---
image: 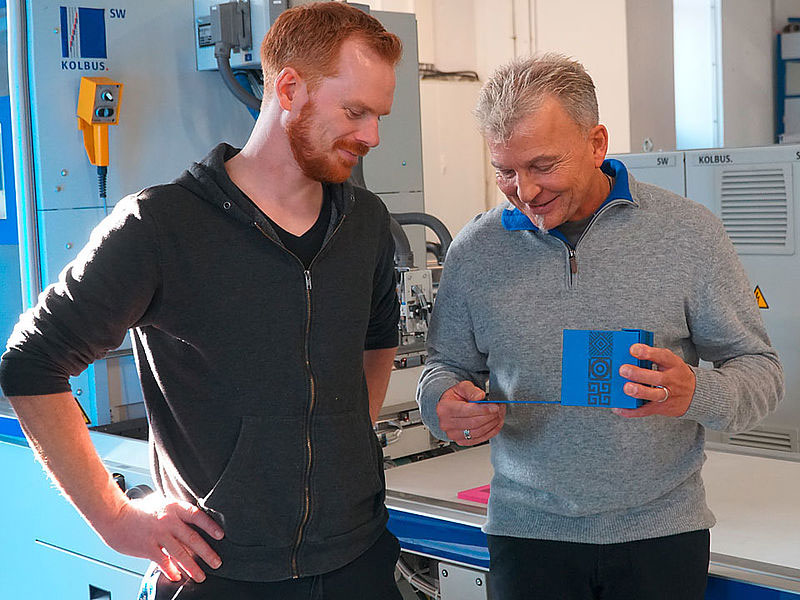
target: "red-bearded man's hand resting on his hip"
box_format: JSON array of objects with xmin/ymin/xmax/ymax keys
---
[{"xmin": 98, "ymin": 498, "xmax": 223, "ymax": 582}]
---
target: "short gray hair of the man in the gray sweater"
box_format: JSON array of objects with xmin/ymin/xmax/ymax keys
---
[{"xmin": 473, "ymin": 52, "xmax": 599, "ymax": 142}]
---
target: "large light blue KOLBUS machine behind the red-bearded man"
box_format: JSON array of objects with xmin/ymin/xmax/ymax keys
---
[{"xmin": 0, "ymin": 0, "xmax": 438, "ymax": 600}]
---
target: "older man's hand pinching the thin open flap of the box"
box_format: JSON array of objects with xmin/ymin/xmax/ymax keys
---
[{"xmin": 436, "ymin": 381, "xmax": 506, "ymax": 446}]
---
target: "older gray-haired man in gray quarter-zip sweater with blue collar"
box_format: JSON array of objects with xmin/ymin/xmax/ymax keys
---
[{"xmin": 418, "ymin": 54, "xmax": 783, "ymax": 600}]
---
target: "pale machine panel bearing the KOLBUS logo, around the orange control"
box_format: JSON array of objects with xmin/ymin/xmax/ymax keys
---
[{"xmin": 27, "ymin": 0, "xmax": 253, "ymax": 296}]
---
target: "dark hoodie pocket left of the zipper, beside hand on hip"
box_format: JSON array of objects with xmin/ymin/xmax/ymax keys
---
[{"xmin": 199, "ymin": 417, "xmax": 304, "ymax": 548}]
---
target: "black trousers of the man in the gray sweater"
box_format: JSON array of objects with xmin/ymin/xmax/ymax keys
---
[{"xmin": 487, "ymin": 529, "xmax": 710, "ymax": 600}]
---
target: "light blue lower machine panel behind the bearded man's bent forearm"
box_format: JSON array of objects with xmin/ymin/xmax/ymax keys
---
[{"xmin": 0, "ymin": 424, "xmax": 154, "ymax": 600}]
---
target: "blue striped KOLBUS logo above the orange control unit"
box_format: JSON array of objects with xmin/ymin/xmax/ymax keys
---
[{"xmin": 60, "ymin": 6, "xmax": 108, "ymax": 71}]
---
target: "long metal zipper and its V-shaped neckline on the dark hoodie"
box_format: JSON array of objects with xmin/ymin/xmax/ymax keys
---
[{"xmin": 253, "ymin": 209, "xmax": 346, "ymax": 579}]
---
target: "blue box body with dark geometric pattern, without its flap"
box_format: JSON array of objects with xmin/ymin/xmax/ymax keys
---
[{"xmin": 561, "ymin": 329, "xmax": 653, "ymax": 408}]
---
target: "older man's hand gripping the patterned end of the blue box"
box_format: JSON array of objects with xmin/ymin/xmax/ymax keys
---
[{"xmin": 612, "ymin": 344, "xmax": 695, "ymax": 417}]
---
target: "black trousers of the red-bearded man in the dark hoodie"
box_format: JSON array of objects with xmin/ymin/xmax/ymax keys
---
[{"xmin": 139, "ymin": 530, "xmax": 402, "ymax": 600}]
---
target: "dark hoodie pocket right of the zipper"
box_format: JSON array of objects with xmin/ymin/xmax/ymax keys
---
[{"xmin": 311, "ymin": 412, "xmax": 384, "ymax": 539}]
